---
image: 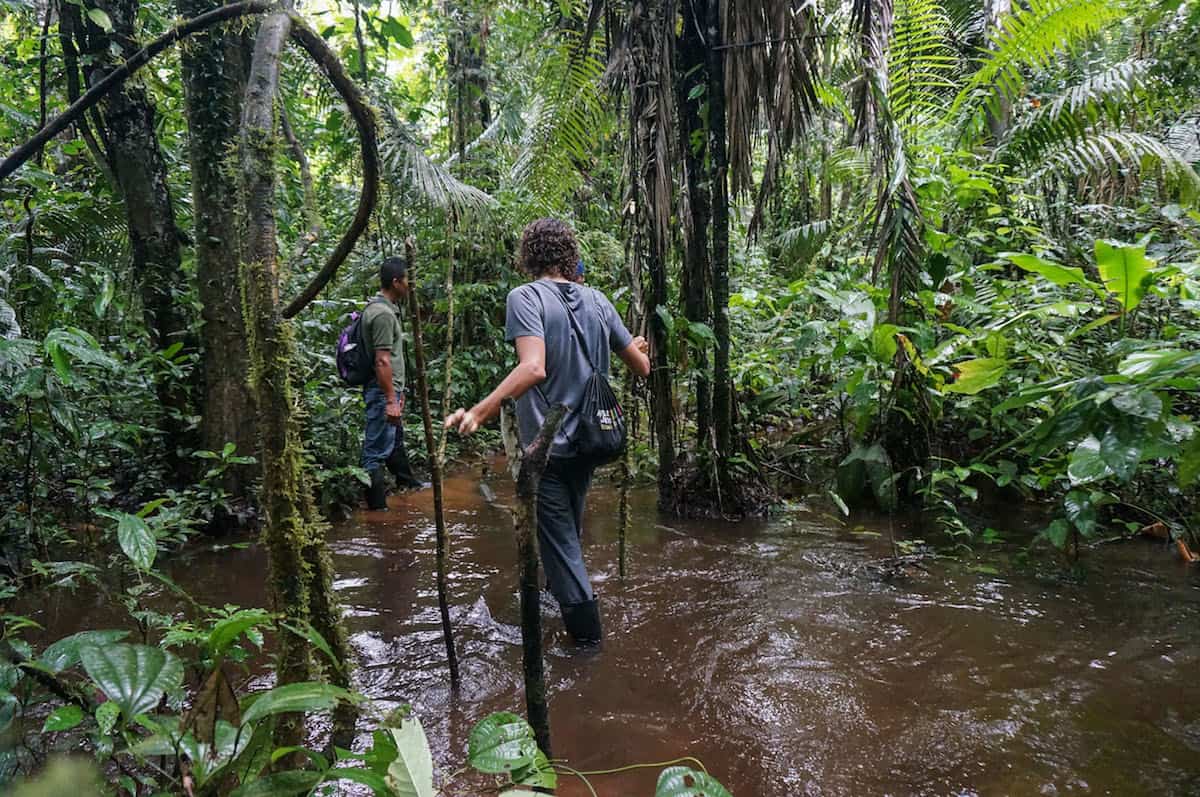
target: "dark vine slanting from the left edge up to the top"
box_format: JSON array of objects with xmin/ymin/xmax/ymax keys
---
[{"xmin": 0, "ymin": 0, "xmax": 275, "ymax": 181}]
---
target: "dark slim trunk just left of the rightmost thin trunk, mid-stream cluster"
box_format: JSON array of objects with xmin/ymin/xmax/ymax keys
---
[{"xmin": 676, "ymin": 2, "xmax": 713, "ymax": 450}]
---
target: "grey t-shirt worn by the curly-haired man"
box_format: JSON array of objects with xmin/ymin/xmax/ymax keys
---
[{"xmin": 504, "ymin": 280, "xmax": 632, "ymax": 456}]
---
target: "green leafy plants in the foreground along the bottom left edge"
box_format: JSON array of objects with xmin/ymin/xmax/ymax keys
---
[{"xmin": 0, "ymin": 607, "xmax": 728, "ymax": 797}]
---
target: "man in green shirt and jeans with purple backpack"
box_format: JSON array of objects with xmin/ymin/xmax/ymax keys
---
[{"xmin": 362, "ymin": 257, "xmax": 424, "ymax": 510}]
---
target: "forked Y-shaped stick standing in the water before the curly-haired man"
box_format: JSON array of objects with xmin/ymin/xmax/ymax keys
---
[{"xmin": 500, "ymin": 399, "xmax": 566, "ymax": 757}]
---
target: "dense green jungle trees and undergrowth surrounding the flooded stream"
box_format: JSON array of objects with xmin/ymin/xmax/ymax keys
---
[{"xmin": 0, "ymin": 0, "xmax": 1200, "ymax": 796}]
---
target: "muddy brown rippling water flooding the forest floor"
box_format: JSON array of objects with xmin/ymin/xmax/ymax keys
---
[{"xmin": 23, "ymin": 472, "xmax": 1200, "ymax": 797}]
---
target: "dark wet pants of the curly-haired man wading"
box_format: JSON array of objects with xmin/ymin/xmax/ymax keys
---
[{"xmin": 538, "ymin": 459, "xmax": 595, "ymax": 606}]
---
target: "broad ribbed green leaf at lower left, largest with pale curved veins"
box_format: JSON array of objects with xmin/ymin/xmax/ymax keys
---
[{"xmin": 79, "ymin": 643, "xmax": 184, "ymax": 720}]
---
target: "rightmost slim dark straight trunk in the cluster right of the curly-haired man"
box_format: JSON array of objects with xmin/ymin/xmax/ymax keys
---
[{"xmin": 706, "ymin": 0, "xmax": 733, "ymax": 494}]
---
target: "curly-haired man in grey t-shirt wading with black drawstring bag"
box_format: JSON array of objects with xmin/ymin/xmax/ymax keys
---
[{"xmin": 445, "ymin": 218, "xmax": 650, "ymax": 645}]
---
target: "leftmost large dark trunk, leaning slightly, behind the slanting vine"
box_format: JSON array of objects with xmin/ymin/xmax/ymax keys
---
[{"xmin": 70, "ymin": 0, "xmax": 190, "ymax": 460}]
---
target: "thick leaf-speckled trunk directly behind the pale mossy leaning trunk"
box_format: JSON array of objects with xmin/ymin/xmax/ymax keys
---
[{"xmin": 176, "ymin": 0, "xmax": 257, "ymax": 498}]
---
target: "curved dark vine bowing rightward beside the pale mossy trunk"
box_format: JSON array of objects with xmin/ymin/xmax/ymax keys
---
[{"xmin": 283, "ymin": 14, "xmax": 379, "ymax": 318}]
